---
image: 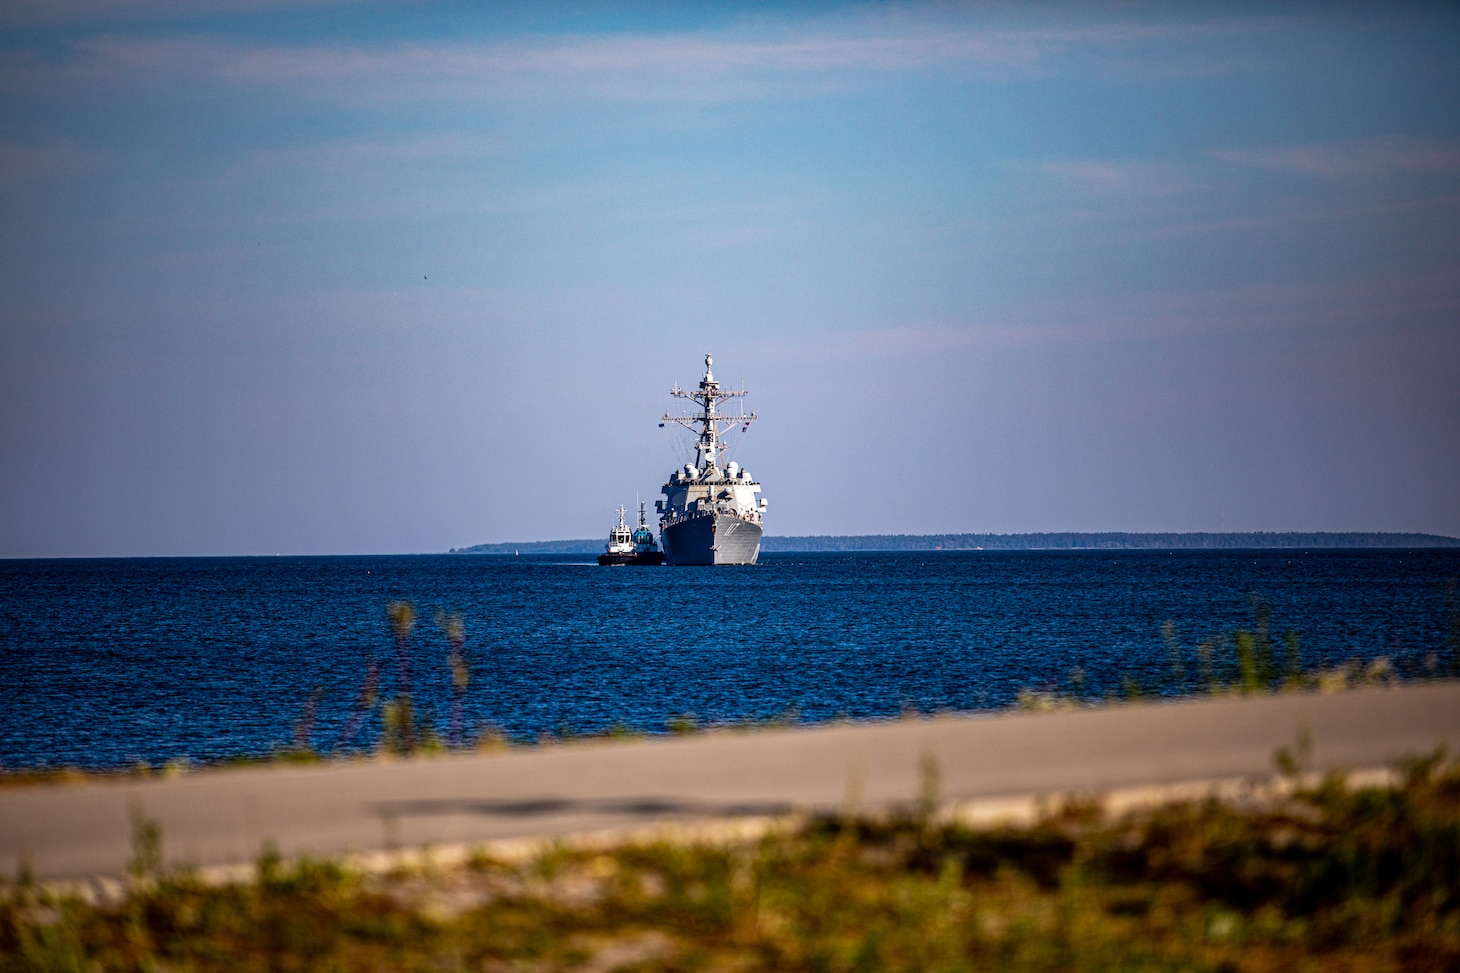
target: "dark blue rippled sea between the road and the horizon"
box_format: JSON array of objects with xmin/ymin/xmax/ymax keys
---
[{"xmin": 0, "ymin": 549, "xmax": 1460, "ymax": 767}]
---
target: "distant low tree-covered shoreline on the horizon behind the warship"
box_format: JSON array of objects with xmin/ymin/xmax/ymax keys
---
[{"xmin": 448, "ymin": 530, "xmax": 1460, "ymax": 554}]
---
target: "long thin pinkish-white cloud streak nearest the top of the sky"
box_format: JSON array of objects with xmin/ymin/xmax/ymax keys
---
[{"xmin": 4, "ymin": 7, "xmax": 1275, "ymax": 99}]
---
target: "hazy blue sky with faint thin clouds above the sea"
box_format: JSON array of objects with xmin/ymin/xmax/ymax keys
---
[{"xmin": 0, "ymin": 0, "xmax": 1460, "ymax": 557}]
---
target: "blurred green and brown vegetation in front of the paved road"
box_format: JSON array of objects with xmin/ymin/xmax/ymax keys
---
[{"xmin": 0, "ymin": 755, "xmax": 1460, "ymax": 970}]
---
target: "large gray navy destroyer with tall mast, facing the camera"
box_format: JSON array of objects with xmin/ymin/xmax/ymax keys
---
[{"xmin": 654, "ymin": 355, "xmax": 765, "ymax": 564}]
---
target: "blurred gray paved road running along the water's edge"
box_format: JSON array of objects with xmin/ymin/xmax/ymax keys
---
[{"xmin": 0, "ymin": 682, "xmax": 1460, "ymax": 879}]
